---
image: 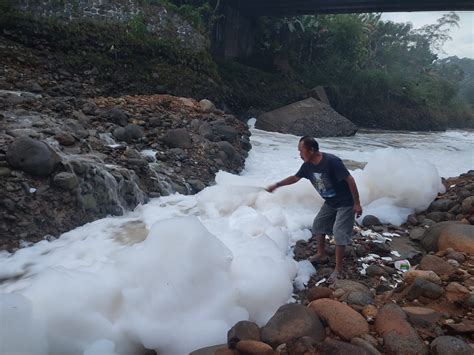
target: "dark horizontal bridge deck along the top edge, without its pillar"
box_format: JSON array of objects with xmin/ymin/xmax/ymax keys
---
[{"xmin": 239, "ymin": 0, "xmax": 474, "ymax": 16}]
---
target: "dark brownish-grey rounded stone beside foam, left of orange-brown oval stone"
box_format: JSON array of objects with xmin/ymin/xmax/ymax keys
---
[{"xmin": 261, "ymin": 301, "xmax": 326, "ymax": 347}]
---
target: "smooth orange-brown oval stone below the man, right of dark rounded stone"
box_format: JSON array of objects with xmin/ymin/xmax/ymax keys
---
[{"xmin": 308, "ymin": 298, "xmax": 369, "ymax": 340}]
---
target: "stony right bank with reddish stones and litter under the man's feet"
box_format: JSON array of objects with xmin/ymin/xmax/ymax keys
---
[{"xmin": 192, "ymin": 171, "xmax": 474, "ymax": 355}]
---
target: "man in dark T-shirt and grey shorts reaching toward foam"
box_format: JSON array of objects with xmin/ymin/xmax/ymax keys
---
[{"xmin": 267, "ymin": 136, "xmax": 362, "ymax": 283}]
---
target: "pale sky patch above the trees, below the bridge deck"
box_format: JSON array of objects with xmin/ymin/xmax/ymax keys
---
[{"xmin": 382, "ymin": 11, "xmax": 474, "ymax": 58}]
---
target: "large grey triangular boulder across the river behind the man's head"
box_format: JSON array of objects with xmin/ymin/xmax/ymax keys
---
[{"xmin": 255, "ymin": 97, "xmax": 357, "ymax": 137}]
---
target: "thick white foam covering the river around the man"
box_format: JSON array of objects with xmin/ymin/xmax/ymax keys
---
[{"xmin": 0, "ymin": 124, "xmax": 474, "ymax": 355}]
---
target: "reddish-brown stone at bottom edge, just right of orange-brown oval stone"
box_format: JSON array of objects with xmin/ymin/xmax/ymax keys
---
[{"xmin": 375, "ymin": 304, "xmax": 428, "ymax": 355}]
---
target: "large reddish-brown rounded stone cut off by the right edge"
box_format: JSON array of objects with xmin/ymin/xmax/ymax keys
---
[{"xmin": 438, "ymin": 223, "xmax": 474, "ymax": 255}]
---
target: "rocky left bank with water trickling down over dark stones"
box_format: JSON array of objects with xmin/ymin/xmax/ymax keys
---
[{"xmin": 0, "ymin": 89, "xmax": 251, "ymax": 250}]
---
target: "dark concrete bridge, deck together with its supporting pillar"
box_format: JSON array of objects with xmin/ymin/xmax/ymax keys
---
[{"xmin": 213, "ymin": 0, "xmax": 474, "ymax": 58}]
